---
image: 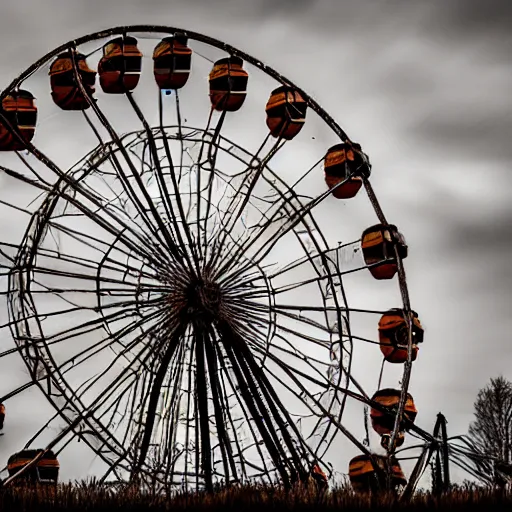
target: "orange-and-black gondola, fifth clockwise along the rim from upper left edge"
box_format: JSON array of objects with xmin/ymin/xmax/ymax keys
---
[{"xmin": 209, "ymin": 57, "xmax": 249, "ymax": 112}]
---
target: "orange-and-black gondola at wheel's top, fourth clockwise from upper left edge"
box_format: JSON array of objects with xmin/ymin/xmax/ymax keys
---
[{"xmin": 153, "ymin": 34, "xmax": 192, "ymax": 89}]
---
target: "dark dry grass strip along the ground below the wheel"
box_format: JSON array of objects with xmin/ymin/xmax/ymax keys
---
[{"xmin": 0, "ymin": 482, "xmax": 512, "ymax": 512}]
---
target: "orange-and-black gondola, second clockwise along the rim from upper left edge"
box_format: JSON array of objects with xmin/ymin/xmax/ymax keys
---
[{"xmin": 49, "ymin": 51, "xmax": 96, "ymax": 110}]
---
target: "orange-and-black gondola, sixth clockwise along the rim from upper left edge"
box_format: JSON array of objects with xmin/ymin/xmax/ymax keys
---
[{"xmin": 265, "ymin": 85, "xmax": 308, "ymax": 140}]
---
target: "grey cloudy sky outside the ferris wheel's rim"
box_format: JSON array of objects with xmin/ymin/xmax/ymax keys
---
[{"xmin": 0, "ymin": 0, "xmax": 512, "ymax": 488}]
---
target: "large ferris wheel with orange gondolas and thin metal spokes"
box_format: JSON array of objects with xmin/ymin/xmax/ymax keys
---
[{"xmin": 0, "ymin": 26, "xmax": 423, "ymax": 489}]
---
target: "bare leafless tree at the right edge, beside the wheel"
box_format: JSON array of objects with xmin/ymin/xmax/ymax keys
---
[{"xmin": 468, "ymin": 376, "xmax": 512, "ymax": 486}]
